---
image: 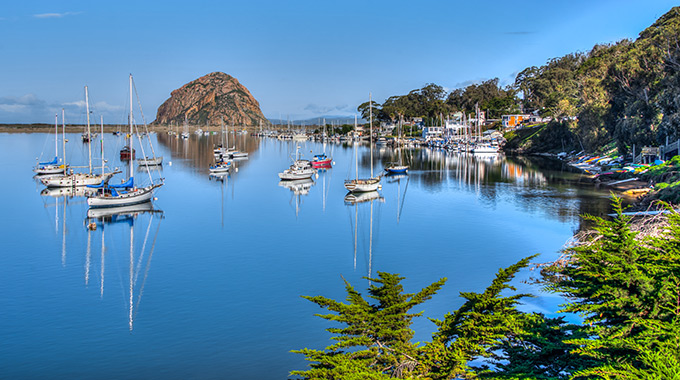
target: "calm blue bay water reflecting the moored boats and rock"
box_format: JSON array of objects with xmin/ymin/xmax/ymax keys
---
[{"xmin": 0, "ymin": 134, "xmax": 608, "ymax": 379}]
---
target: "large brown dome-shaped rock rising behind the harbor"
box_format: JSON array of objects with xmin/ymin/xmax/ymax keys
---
[{"xmin": 154, "ymin": 72, "xmax": 267, "ymax": 126}]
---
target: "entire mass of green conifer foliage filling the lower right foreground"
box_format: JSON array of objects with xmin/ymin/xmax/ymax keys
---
[{"xmin": 291, "ymin": 198, "xmax": 680, "ymax": 380}]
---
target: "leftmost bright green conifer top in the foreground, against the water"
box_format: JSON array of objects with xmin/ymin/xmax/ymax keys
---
[{"xmin": 292, "ymin": 272, "xmax": 446, "ymax": 379}]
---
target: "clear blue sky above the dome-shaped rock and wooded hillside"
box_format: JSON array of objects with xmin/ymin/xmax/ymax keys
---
[{"xmin": 0, "ymin": 0, "xmax": 676, "ymax": 124}]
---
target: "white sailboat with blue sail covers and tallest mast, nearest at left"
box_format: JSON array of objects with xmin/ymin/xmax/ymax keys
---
[{"xmin": 87, "ymin": 74, "xmax": 163, "ymax": 207}]
